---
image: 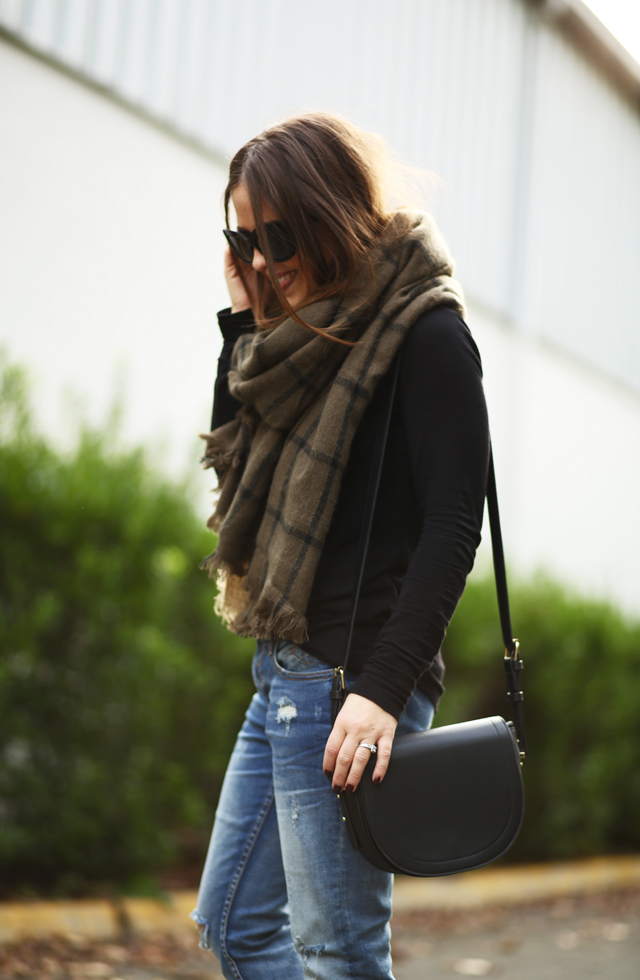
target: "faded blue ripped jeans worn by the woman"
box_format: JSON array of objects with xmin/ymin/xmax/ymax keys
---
[{"xmin": 192, "ymin": 641, "xmax": 433, "ymax": 980}]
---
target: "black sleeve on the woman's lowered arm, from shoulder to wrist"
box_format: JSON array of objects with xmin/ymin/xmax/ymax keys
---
[{"xmin": 352, "ymin": 307, "xmax": 489, "ymax": 718}]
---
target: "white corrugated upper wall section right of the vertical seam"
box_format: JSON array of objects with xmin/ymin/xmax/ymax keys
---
[{"xmin": 521, "ymin": 21, "xmax": 640, "ymax": 385}]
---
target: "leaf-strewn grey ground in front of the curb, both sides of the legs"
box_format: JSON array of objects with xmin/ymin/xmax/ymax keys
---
[{"xmin": 0, "ymin": 890, "xmax": 640, "ymax": 980}]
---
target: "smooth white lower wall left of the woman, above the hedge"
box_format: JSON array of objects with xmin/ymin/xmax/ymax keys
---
[{"xmin": 0, "ymin": 42, "xmax": 227, "ymax": 483}]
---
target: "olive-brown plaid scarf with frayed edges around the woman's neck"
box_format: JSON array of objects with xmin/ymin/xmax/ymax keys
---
[{"xmin": 203, "ymin": 211, "xmax": 464, "ymax": 643}]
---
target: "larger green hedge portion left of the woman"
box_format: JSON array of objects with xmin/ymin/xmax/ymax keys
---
[{"xmin": 0, "ymin": 360, "xmax": 252, "ymax": 894}]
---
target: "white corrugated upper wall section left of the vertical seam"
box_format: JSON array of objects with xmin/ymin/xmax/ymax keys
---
[{"xmin": 0, "ymin": 0, "xmax": 524, "ymax": 312}]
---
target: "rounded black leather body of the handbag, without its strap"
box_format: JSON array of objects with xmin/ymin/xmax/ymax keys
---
[{"xmin": 355, "ymin": 716, "xmax": 524, "ymax": 875}]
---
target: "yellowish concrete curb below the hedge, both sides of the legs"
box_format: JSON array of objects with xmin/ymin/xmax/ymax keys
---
[{"xmin": 0, "ymin": 856, "xmax": 640, "ymax": 943}]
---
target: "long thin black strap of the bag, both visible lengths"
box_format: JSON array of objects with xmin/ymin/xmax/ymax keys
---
[{"xmin": 338, "ymin": 353, "xmax": 526, "ymax": 758}]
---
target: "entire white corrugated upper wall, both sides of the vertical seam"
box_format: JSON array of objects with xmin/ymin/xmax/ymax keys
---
[{"xmin": 0, "ymin": 0, "xmax": 640, "ymax": 385}]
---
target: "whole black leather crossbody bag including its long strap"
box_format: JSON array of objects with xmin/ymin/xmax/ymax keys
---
[{"xmin": 331, "ymin": 356, "xmax": 526, "ymax": 878}]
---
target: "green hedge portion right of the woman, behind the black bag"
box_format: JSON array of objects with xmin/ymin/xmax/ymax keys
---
[{"xmin": 437, "ymin": 578, "xmax": 640, "ymax": 860}]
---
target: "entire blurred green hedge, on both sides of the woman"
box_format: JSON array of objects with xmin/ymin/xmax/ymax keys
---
[{"xmin": 0, "ymin": 360, "xmax": 640, "ymax": 896}]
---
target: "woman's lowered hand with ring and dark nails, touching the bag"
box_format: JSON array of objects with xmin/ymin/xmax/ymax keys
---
[{"xmin": 322, "ymin": 694, "xmax": 398, "ymax": 793}]
